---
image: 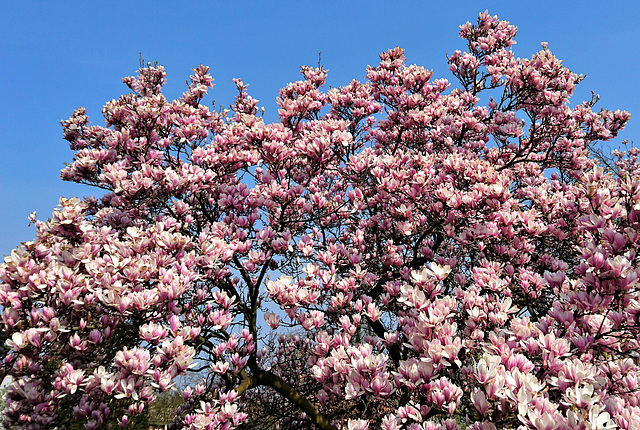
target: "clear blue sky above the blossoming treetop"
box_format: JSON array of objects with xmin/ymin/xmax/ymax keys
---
[{"xmin": 0, "ymin": 0, "xmax": 640, "ymax": 254}]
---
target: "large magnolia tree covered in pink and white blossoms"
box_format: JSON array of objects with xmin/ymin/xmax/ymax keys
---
[{"xmin": 0, "ymin": 13, "xmax": 640, "ymax": 430}]
